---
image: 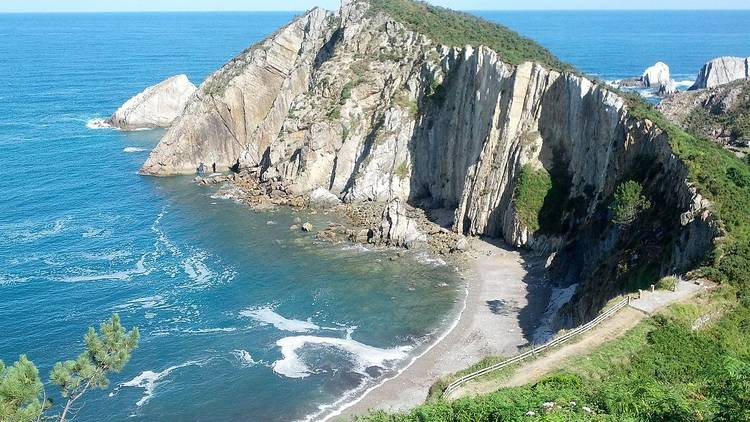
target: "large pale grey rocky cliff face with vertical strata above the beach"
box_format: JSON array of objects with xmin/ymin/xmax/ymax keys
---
[{"xmin": 142, "ymin": 0, "xmax": 715, "ymax": 319}]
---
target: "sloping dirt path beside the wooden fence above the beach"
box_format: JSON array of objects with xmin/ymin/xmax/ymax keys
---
[{"xmin": 449, "ymin": 283, "xmax": 702, "ymax": 399}]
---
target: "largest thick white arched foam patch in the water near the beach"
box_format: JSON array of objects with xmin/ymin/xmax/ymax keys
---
[{"xmin": 271, "ymin": 335, "xmax": 412, "ymax": 378}]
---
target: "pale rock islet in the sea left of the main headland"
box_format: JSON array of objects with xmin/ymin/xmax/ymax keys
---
[{"xmin": 107, "ymin": 75, "xmax": 197, "ymax": 129}]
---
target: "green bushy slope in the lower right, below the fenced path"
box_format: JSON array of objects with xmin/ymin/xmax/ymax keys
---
[{"xmin": 360, "ymin": 288, "xmax": 750, "ymax": 422}]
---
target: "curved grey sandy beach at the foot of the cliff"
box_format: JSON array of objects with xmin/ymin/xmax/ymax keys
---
[{"xmin": 328, "ymin": 239, "xmax": 549, "ymax": 420}]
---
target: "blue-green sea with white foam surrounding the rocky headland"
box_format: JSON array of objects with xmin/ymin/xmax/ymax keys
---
[{"xmin": 0, "ymin": 7, "xmax": 750, "ymax": 421}]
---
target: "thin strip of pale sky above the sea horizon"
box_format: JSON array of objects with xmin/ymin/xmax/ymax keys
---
[{"xmin": 0, "ymin": 0, "xmax": 750, "ymax": 13}]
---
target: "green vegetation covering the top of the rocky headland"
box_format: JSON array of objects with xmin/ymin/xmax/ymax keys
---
[{"xmin": 369, "ymin": 0, "xmax": 572, "ymax": 70}]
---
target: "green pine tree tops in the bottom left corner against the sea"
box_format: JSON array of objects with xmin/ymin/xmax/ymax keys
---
[{"xmin": 0, "ymin": 314, "xmax": 139, "ymax": 422}]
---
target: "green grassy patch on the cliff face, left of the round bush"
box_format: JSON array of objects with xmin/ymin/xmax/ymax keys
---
[{"xmin": 513, "ymin": 164, "xmax": 552, "ymax": 232}]
